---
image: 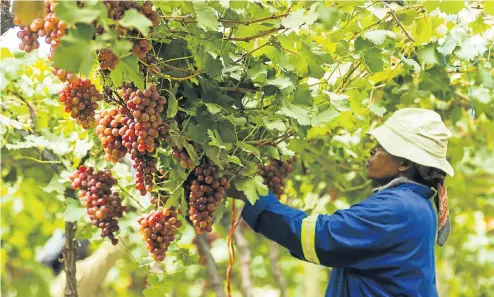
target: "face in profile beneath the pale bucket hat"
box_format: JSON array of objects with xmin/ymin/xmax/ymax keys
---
[{"xmin": 365, "ymin": 145, "xmax": 402, "ymax": 182}]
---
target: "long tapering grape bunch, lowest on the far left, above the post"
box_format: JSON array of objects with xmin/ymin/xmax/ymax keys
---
[{"xmin": 69, "ymin": 166, "xmax": 126, "ymax": 245}]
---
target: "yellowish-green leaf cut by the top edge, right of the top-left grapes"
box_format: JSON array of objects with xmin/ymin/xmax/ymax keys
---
[{"xmin": 57, "ymin": 1, "xmax": 108, "ymax": 25}]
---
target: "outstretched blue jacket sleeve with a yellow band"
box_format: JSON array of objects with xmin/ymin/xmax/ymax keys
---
[{"xmin": 242, "ymin": 193, "xmax": 408, "ymax": 268}]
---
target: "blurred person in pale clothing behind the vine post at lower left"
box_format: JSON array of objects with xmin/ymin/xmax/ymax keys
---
[{"xmin": 37, "ymin": 230, "xmax": 125, "ymax": 297}]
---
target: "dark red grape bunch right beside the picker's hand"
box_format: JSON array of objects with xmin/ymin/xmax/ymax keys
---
[{"xmin": 185, "ymin": 164, "xmax": 230, "ymax": 234}]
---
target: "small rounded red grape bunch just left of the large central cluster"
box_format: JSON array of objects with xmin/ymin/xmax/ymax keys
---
[{"xmin": 59, "ymin": 78, "xmax": 103, "ymax": 129}]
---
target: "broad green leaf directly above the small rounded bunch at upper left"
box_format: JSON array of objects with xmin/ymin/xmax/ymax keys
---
[{"xmin": 53, "ymin": 24, "xmax": 96, "ymax": 75}]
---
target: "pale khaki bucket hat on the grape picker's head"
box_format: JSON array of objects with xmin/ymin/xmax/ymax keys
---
[{"xmin": 369, "ymin": 108, "xmax": 454, "ymax": 176}]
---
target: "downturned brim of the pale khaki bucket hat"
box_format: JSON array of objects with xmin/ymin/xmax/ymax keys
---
[{"xmin": 367, "ymin": 125, "xmax": 455, "ymax": 176}]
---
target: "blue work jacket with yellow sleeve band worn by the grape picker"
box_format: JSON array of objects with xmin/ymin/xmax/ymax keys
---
[{"xmin": 242, "ymin": 183, "xmax": 438, "ymax": 297}]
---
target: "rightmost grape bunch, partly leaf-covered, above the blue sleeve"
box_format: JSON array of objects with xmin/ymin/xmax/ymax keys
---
[{"xmin": 259, "ymin": 157, "xmax": 296, "ymax": 199}]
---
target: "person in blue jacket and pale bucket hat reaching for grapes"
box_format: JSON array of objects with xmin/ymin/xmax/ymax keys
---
[{"xmin": 229, "ymin": 108, "xmax": 454, "ymax": 297}]
